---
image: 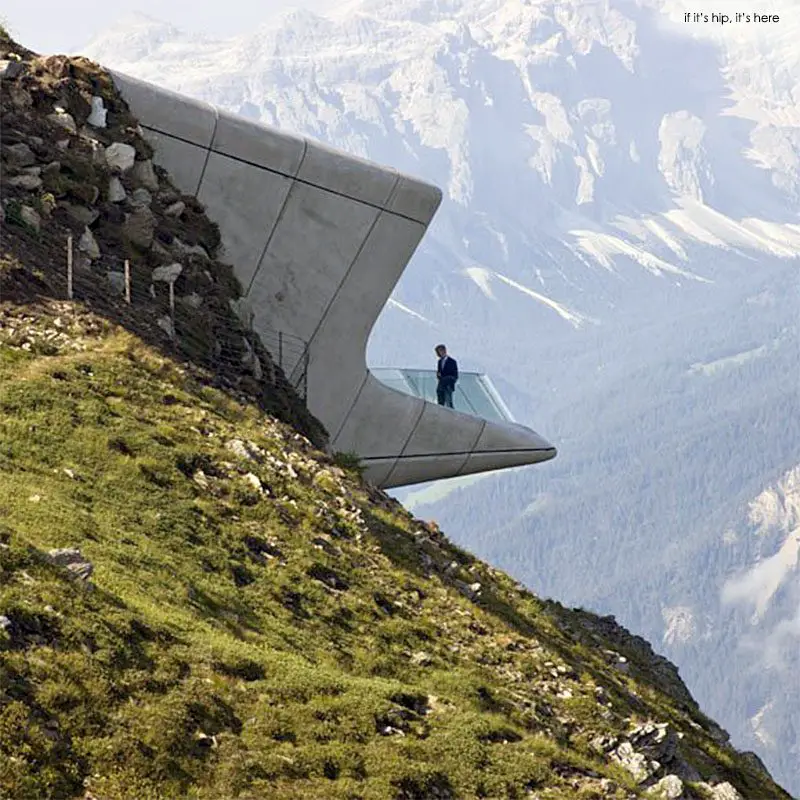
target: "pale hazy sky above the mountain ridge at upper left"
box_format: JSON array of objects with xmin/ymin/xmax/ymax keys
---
[{"xmin": 0, "ymin": 0, "xmax": 335, "ymax": 53}]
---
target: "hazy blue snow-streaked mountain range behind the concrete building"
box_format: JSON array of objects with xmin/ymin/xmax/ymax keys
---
[{"xmin": 83, "ymin": 0, "xmax": 800, "ymax": 792}]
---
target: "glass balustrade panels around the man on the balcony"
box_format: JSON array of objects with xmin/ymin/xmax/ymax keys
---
[{"xmin": 370, "ymin": 367, "xmax": 515, "ymax": 422}]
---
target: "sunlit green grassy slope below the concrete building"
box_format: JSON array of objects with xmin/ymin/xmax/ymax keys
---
[{"xmin": 0, "ymin": 304, "xmax": 786, "ymax": 800}]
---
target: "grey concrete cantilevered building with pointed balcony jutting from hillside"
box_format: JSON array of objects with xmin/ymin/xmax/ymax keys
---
[{"xmin": 112, "ymin": 73, "xmax": 556, "ymax": 488}]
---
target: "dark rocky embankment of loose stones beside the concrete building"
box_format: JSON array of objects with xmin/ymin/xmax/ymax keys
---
[{"xmin": 0, "ymin": 29, "xmax": 327, "ymax": 447}]
